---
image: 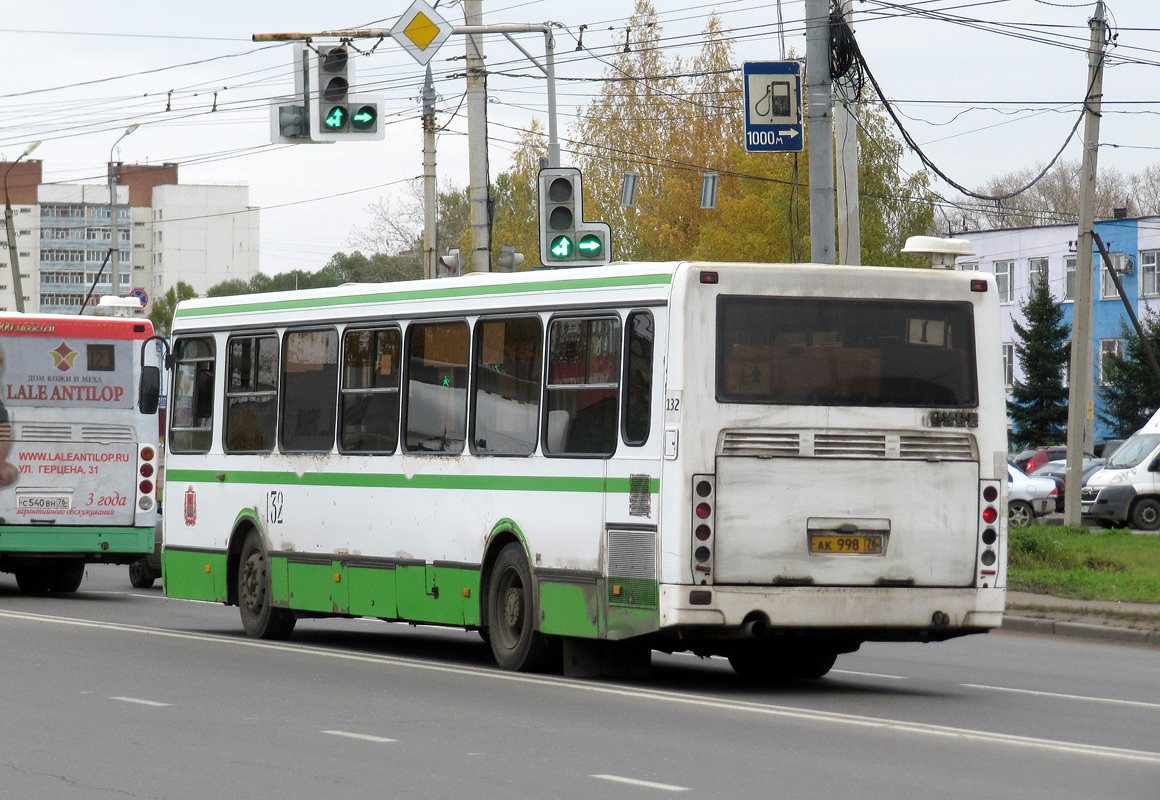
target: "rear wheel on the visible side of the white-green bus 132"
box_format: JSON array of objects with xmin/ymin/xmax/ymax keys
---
[{"xmin": 487, "ymin": 541, "xmax": 560, "ymax": 672}]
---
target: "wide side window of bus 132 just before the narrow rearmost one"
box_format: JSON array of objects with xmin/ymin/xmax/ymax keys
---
[{"xmin": 544, "ymin": 317, "xmax": 621, "ymax": 456}]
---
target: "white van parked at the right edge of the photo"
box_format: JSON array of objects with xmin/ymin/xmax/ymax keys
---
[{"xmin": 1080, "ymin": 410, "xmax": 1160, "ymax": 531}]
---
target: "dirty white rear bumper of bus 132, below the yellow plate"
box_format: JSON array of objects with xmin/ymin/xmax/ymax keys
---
[{"xmin": 660, "ymin": 584, "xmax": 1006, "ymax": 641}]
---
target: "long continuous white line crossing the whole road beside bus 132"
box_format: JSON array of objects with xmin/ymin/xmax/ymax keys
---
[{"xmin": 0, "ymin": 610, "xmax": 1160, "ymax": 765}]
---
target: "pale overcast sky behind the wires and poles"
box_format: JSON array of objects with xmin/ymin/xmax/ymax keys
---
[{"xmin": 0, "ymin": 0, "xmax": 1160, "ymax": 280}]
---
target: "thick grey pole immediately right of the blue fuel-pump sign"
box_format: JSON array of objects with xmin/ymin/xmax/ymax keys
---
[{"xmin": 805, "ymin": 0, "xmax": 834, "ymax": 264}]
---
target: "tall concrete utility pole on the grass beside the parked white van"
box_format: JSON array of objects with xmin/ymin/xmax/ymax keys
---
[{"xmin": 1064, "ymin": 1, "xmax": 1104, "ymax": 528}]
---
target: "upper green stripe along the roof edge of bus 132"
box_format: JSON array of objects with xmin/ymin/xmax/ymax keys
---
[{"xmin": 174, "ymin": 272, "xmax": 673, "ymax": 319}]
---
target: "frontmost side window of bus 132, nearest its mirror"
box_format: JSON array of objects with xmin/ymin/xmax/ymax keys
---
[{"xmin": 169, "ymin": 337, "xmax": 213, "ymax": 453}]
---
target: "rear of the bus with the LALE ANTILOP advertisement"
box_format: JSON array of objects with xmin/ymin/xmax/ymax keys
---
[{"xmin": 0, "ymin": 314, "xmax": 158, "ymax": 592}]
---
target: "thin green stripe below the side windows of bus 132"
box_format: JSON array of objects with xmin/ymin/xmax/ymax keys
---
[{"xmin": 166, "ymin": 467, "xmax": 660, "ymax": 494}]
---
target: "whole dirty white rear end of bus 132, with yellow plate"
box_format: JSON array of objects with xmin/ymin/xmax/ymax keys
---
[{"xmin": 661, "ymin": 259, "xmax": 1006, "ymax": 674}]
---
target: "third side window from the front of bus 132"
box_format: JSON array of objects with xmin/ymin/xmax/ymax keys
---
[{"xmin": 281, "ymin": 330, "xmax": 339, "ymax": 452}]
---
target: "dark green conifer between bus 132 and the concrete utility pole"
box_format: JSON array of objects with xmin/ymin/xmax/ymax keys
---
[{"xmin": 1007, "ymin": 273, "xmax": 1071, "ymax": 448}]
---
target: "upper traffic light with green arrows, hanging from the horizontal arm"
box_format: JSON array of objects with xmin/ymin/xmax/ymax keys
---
[{"xmin": 309, "ymin": 44, "xmax": 386, "ymax": 141}]
